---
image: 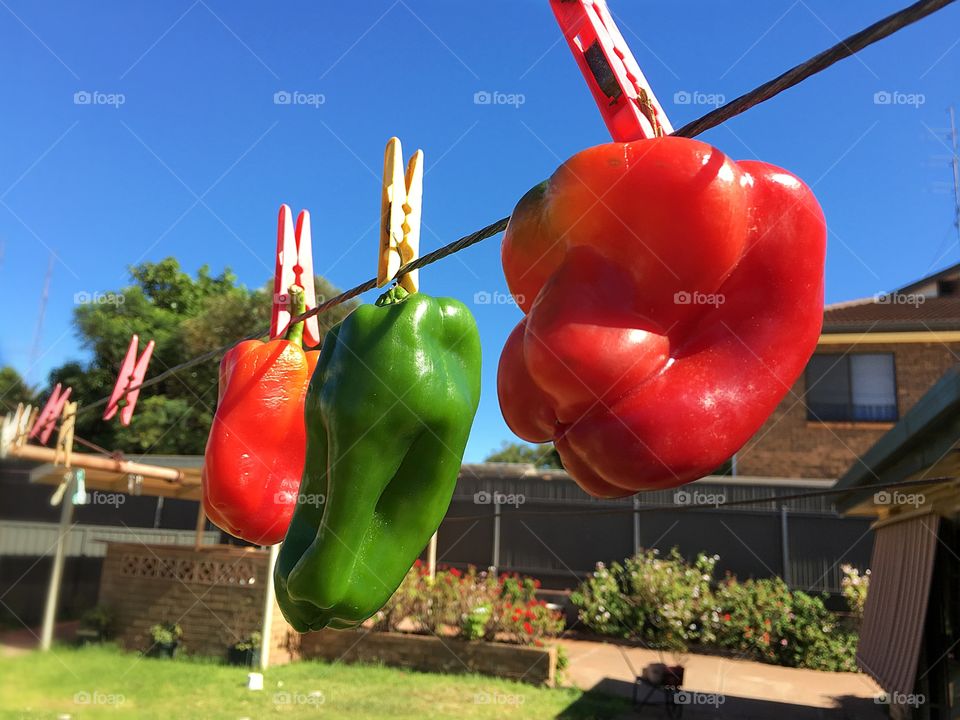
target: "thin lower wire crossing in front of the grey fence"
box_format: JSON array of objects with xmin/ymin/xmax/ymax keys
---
[{"xmin": 443, "ymin": 477, "xmax": 960, "ymax": 522}]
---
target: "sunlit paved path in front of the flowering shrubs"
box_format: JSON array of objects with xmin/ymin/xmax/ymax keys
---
[{"xmin": 560, "ymin": 640, "xmax": 887, "ymax": 720}]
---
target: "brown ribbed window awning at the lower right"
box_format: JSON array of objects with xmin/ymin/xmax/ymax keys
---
[{"xmin": 857, "ymin": 514, "xmax": 940, "ymax": 695}]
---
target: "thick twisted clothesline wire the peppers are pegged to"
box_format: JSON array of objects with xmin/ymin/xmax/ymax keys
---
[{"xmin": 28, "ymin": 0, "xmax": 956, "ymax": 417}]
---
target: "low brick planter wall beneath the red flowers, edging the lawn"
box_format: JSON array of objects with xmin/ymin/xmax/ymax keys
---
[{"xmin": 301, "ymin": 630, "xmax": 557, "ymax": 685}]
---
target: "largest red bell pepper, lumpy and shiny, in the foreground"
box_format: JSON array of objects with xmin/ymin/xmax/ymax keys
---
[{"xmin": 498, "ymin": 137, "xmax": 826, "ymax": 497}]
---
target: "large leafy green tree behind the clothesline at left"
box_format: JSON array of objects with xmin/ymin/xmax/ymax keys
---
[{"xmin": 44, "ymin": 258, "xmax": 353, "ymax": 455}]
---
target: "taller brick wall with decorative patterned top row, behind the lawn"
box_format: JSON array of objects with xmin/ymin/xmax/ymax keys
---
[{"xmin": 99, "ymin": 543, "xmax": 299, "ymax": 664}]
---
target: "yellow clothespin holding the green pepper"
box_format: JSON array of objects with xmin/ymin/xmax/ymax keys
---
[{"xmin": 377, "ymin": 137, "xmax": 423, "ymax": 292}]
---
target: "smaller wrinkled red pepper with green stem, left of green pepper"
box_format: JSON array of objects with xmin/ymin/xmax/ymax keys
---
[{"xmin": 203, "ymin": 293, "xmax": 323, "ymax": 545}]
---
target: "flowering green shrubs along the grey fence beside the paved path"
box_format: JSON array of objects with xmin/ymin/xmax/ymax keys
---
[{"xmin": 571, "ymin": 549, "xmax": 857, "ymax": 670}]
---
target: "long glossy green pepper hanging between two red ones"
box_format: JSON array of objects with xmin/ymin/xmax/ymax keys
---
[{"xmin": 274, "ymin": 287, "xmax": 480, "ymax": 632}]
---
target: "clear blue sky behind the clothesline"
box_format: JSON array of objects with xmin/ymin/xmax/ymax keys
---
[{"xmin": 0, "ymin": 0, "xmax": 960, "ymax": 460}]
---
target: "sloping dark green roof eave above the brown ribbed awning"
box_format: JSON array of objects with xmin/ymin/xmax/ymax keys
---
[{"xmin": 835, "ymin": 366, "xmax": 960, "ymax": 514}]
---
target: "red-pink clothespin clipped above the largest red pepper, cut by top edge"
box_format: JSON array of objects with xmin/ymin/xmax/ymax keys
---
[{"xmin": 550, "ymin": 0, "xmax": 673, "ymax": 142}]
